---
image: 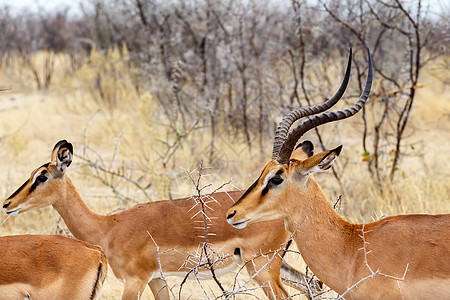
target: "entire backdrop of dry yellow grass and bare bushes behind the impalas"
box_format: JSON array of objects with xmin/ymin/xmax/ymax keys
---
[{"xmin": 0, "ymin": 0, "xmax": 450, "ymax": 299}]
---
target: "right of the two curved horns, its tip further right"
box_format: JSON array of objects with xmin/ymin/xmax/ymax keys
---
[{"xmin": 277, "ymin": 49, "xmax": 373, "ymax": 164}]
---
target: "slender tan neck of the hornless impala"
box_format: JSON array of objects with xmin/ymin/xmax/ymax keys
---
[{"xmin": 53, "ymin": 177, "xmax": 109, "ymax": 246}]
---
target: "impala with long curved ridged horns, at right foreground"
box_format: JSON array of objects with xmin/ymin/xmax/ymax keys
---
[{"xmin": 227, "ymin": 48, "xmax": 450, "ymax": 299}]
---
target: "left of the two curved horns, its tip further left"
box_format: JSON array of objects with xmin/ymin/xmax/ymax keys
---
[{"xmin": 272, "ymin": 48, "xmax": 352, "ymax": 159}]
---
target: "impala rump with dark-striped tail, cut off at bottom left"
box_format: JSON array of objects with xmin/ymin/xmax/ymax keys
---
[{"xmin": 0, "ymin": 235, "xmax": 108, "ymax": 300}]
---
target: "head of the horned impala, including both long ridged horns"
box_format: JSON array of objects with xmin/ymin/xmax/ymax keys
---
[{"xmin": 227, "ymin": 49, "xmax": 372, "ymax": 228}]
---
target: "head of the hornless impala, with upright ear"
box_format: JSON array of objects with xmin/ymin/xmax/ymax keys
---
[{"xmin": 3, "ymin": 140, "xmax": 73, "ymax": 216}]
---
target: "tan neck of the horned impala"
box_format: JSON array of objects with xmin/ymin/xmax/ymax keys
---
[{"xmin": 285, "ymin": 178, "xmax": 358, "ymax": 293}]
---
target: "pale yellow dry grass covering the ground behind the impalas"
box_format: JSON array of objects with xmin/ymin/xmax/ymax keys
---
[{"xmin": 0, "ymin": 53, "xmax": 450, "ymax": 299}]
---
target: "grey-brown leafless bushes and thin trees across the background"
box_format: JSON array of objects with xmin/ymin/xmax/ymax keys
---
[{"xmin": 0, "ymin": 0, "xmax": 449, "ymax": 178}]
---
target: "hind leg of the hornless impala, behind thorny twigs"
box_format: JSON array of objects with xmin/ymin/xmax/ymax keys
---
[{"xmin": 247, "ymin": 256, "xmax": 289, "ymax": 299}]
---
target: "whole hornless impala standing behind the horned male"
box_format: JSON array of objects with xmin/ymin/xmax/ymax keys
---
[{"xmin": 3, "ymin": 140, "xmax": 316, "ymax": 299}]
